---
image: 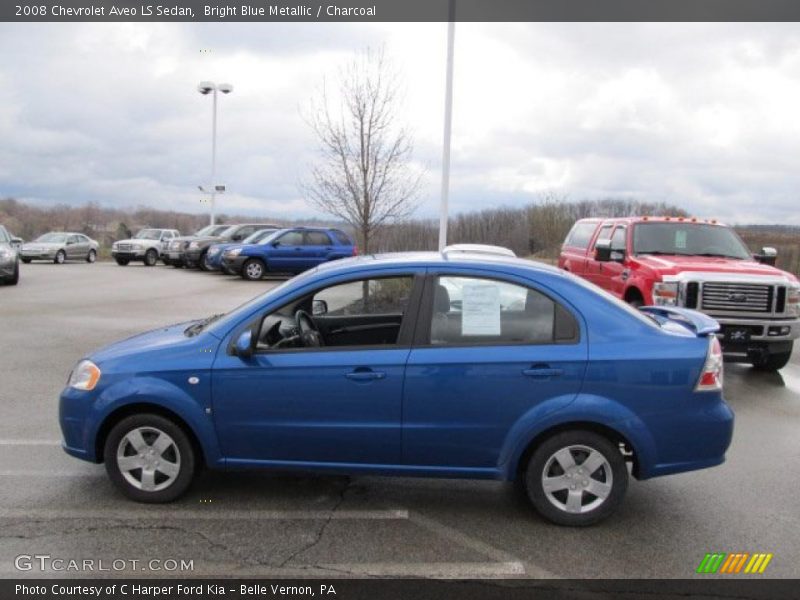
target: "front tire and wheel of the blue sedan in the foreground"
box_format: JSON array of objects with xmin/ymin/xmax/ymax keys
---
[{"xmin": 103, "ymin": 413, "xmax": 195, "ymax": 503}]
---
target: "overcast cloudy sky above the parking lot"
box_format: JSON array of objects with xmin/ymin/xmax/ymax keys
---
[{"xmin": 0, "ymin": 23, "xmax": 800, "ymax": 224}]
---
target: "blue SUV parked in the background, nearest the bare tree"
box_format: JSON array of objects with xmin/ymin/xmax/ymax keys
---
[{"xmin": 222, "ymin": 227, "xmax": 358, "ymax": 281}]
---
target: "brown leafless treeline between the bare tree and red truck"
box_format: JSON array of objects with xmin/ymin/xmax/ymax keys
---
[{"xmin": 376, "ymin": 196, "xmax": 687, "ymax": 258}]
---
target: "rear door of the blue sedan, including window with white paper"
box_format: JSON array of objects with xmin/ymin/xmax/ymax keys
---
[{"xmin": 403, "ymin": 270, "xmax": 587, "ymax": 472}]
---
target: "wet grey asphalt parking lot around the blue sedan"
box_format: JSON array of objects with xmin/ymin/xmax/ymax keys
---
[{"xmin": 0, "ymin": 263, "xmax": 800, "ymax": 578}]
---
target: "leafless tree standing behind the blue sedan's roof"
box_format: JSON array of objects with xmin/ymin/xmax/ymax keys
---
[{"xmin": 301, "ymin": 50, "xmax": 422, "ymax": 253}]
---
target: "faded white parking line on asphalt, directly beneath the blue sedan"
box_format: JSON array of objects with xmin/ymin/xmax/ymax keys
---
[{"xmin": 0, "ymin": 508, "xmax": 408, "ymax": 521}]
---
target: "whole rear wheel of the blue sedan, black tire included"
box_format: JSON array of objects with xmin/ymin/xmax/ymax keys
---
[{"xmin": 524, "ymin": 430, "xmax": 628, "ymax": 527}]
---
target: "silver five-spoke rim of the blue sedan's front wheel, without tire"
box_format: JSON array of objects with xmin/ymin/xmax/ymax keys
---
[{"xmin": 117, "ymin": 427, "xmax": 181, "ymax": 492}]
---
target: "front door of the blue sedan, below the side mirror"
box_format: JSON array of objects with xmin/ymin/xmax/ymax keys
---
[{"xmin": 212, "ymin": 273, "xmax": 422, "ymax": 465}]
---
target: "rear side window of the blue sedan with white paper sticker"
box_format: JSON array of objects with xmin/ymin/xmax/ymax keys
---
[{"xmin": 430, "ymin": 276, "xmax": 578, "ymax": 346}]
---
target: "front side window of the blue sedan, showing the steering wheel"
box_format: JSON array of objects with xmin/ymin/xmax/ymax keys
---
[{"xmin": 256, "ymin": 275, "xmax": 414, "ymax": 352}]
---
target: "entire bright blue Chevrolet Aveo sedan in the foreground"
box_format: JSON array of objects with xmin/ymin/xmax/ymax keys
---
[{"xmin": 60, "ymin": 253, "xmax": 733, "ymax": 525}]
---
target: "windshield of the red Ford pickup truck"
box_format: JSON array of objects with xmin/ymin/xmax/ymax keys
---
[{"xmin": 633, "ymin": 222, "xmax": 750, "ymax": 259}]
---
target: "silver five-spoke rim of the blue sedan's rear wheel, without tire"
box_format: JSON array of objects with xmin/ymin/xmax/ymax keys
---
[{"xmin": 542, "ymin": 445, "xmax": 614, "ymax": 514}]
